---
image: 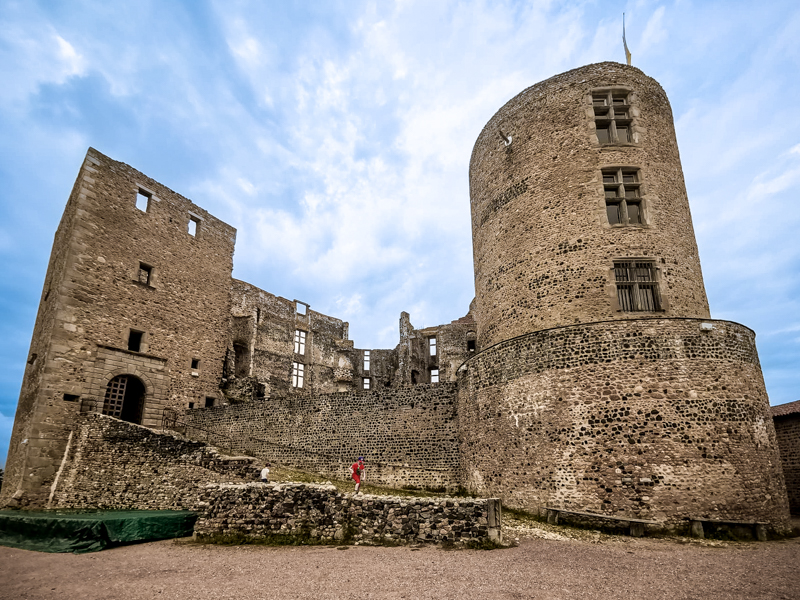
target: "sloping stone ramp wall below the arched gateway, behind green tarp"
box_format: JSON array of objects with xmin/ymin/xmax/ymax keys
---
[{"xmin": 49, "ymin": 414, "xmax": 258, "ymax": 510}]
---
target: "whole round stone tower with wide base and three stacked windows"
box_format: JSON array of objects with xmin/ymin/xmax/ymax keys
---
[{"xmin": 459, "ymin": 63, "xmax": 788, "ymax": 530}]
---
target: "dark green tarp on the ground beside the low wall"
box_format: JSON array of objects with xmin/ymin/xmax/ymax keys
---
[{"xmin": 0, "ymin": 510, "xmax": 197, "ymax": 554}]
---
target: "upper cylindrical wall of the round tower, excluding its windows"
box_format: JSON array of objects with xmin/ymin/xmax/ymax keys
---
[{"xmin": 470, "ymin": 63, "xmax": 709, "ymax": 348}]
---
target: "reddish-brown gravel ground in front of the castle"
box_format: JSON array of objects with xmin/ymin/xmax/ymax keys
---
[{"xmin": 0, "ymin": 519, "xmax": 800, "ymax": 600}]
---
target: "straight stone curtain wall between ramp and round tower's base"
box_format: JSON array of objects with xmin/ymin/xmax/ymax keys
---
[{"xmin": 186, "ymin": 383, "xmax": 458, "ymax": 489}]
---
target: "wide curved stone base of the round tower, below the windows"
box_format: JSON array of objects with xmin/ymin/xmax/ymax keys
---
[{"xmin": 458, "ymin": 319, "xmax": 788, "ymax": 530}]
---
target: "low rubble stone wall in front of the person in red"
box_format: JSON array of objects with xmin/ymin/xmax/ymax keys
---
[{"xmin": 193, "ymin": 483, "xmax": 501, "ymax": 546}]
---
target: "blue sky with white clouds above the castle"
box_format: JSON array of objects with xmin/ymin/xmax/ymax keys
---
[{"xmin": 0, "ymin": 0, "xmax": 800, "ymax": 464}]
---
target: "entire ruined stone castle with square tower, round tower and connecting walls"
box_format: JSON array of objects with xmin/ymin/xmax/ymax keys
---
[{"xmin": 3, "ymin": 63, "xmax": 789, "ymax": 530}]
